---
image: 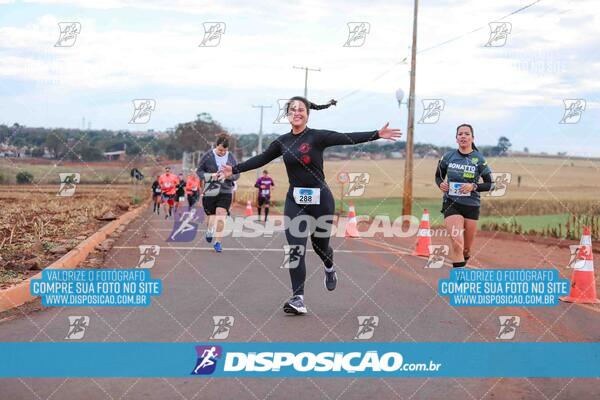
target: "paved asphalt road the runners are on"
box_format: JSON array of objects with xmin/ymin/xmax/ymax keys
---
[{"xmin": 0, "ymin": 203, "xmax": 600, "ymax": 400}]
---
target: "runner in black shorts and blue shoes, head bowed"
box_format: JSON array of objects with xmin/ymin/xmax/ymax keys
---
[{"xmin": 196, "ymin": 134, "xmax": 240, "ymax": 253}]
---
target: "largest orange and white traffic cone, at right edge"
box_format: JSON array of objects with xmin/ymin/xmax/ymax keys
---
[{"xmin": 560, "ymin": 226, "xmax": 600, "ymax": 304}]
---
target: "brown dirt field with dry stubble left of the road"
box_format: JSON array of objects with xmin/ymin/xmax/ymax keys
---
[{"xmin": 0, "ymin": 185, "xmax": 143, "ymax": 289}]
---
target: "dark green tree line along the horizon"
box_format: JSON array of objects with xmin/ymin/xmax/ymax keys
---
[{"xmin": 0, "ymin": 117, "xmax": 511, "ymax": 161}]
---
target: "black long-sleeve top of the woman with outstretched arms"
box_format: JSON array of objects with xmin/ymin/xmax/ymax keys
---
[{"xmin": 233, "ymin": 127, "xmax": 379, "ymax": 188}]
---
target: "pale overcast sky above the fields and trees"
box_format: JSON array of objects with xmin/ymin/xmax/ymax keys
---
[{"xmin": 0, "ymin": 0, "xmax": 600, "ymax": 156}]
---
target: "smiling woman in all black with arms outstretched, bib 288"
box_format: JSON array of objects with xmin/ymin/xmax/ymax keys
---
[{"xmin": 222, "ymin": 96, "xmax": 400, "ymax": 314}]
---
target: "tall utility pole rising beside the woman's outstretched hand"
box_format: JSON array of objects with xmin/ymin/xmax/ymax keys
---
[{"xmin": 402, "ymin": 0, "xmax": 419, "ymax": 219}]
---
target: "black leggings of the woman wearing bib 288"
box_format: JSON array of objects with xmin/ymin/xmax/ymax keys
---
[{"xmin": 284, "ymin": 187, "xmax": 335, "ymax": 295}]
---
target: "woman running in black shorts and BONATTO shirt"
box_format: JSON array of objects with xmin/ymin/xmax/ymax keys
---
[{"xmin": 435, "ymin": 124, "xmax": 492, "ymax": 268}]
